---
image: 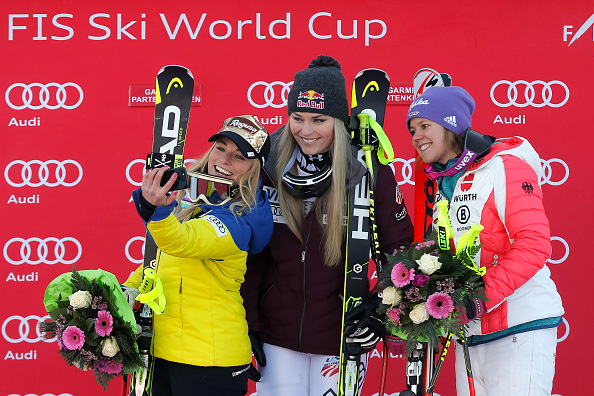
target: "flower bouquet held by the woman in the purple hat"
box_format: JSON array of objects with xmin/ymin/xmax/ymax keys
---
[{"xmin": 378, "ymin": 233, "xmax": 487, "ymax": 357}]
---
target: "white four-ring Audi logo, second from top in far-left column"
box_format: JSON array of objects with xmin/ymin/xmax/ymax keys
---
[{"xmin": 4, "ymin": 160, "xmax": 83, "ymax": 187}]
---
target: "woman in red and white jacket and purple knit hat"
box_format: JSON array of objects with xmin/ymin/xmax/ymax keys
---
[{"xmin": 407, "ymin": 87, "xmax": 564, "ymax": 396}]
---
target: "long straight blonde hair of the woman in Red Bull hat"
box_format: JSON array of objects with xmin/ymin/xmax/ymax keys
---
[{"xmin": 275, "ymin": 118, "xmax": 351, "ymax": 267}]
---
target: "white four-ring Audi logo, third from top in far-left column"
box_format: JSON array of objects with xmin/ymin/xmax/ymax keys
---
[{"xmin": 3, "ymin": 237, "xmax": 82, "ymax": 265}]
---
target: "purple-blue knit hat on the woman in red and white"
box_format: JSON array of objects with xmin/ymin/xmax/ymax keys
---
[{"xmin": 406, "ymin": 87, "xmax": 474, "ymax": 135}]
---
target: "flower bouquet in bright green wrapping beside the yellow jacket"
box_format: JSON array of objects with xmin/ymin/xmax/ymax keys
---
[{"xmin": 40, "ymin": 268, "xmax": 144, "ymax": 390}]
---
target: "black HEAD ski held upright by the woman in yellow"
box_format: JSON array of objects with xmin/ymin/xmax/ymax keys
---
[{"xmin": 128, "ymin": 65, "xmax": 194, "ymax": 396}]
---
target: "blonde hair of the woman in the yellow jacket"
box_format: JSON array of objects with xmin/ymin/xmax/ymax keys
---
[{"xmin": 175, "ymin": 142, "xmax": 261, "ymax": 222}]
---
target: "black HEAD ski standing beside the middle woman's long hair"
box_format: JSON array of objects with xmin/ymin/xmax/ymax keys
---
[{"xmin": 338, "ymin": 69, "xmax": 393, "ymax": 396}]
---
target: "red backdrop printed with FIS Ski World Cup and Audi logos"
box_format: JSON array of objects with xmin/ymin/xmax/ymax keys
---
[{"xmin": 0, "ymin": 0, "xmax": 594, "ymax": 396}]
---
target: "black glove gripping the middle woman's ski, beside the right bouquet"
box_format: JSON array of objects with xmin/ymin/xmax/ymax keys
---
[{"xmin": 345, "ymin": 294, "xmax": 386, "ymax": 355}]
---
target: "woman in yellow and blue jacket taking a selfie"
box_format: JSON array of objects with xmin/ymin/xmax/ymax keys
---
[{"xmin": 124, "ymin": 116, "xmax": 273, "ymax": 396}]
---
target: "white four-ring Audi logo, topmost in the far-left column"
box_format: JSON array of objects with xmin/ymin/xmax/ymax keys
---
[{"xmin": 4, "ymin": 82, "xmax": 84, "ymax": 110}]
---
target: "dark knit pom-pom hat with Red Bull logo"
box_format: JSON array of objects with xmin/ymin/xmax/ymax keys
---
[{"xmin": 287, "ymin": 55, "xmax": 349, "ymax": 122}]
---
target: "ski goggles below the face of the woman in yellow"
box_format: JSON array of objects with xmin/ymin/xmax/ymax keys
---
[{"xmin": 184, "ymin": 172, "xmax": 239, "ymax": 205}]
